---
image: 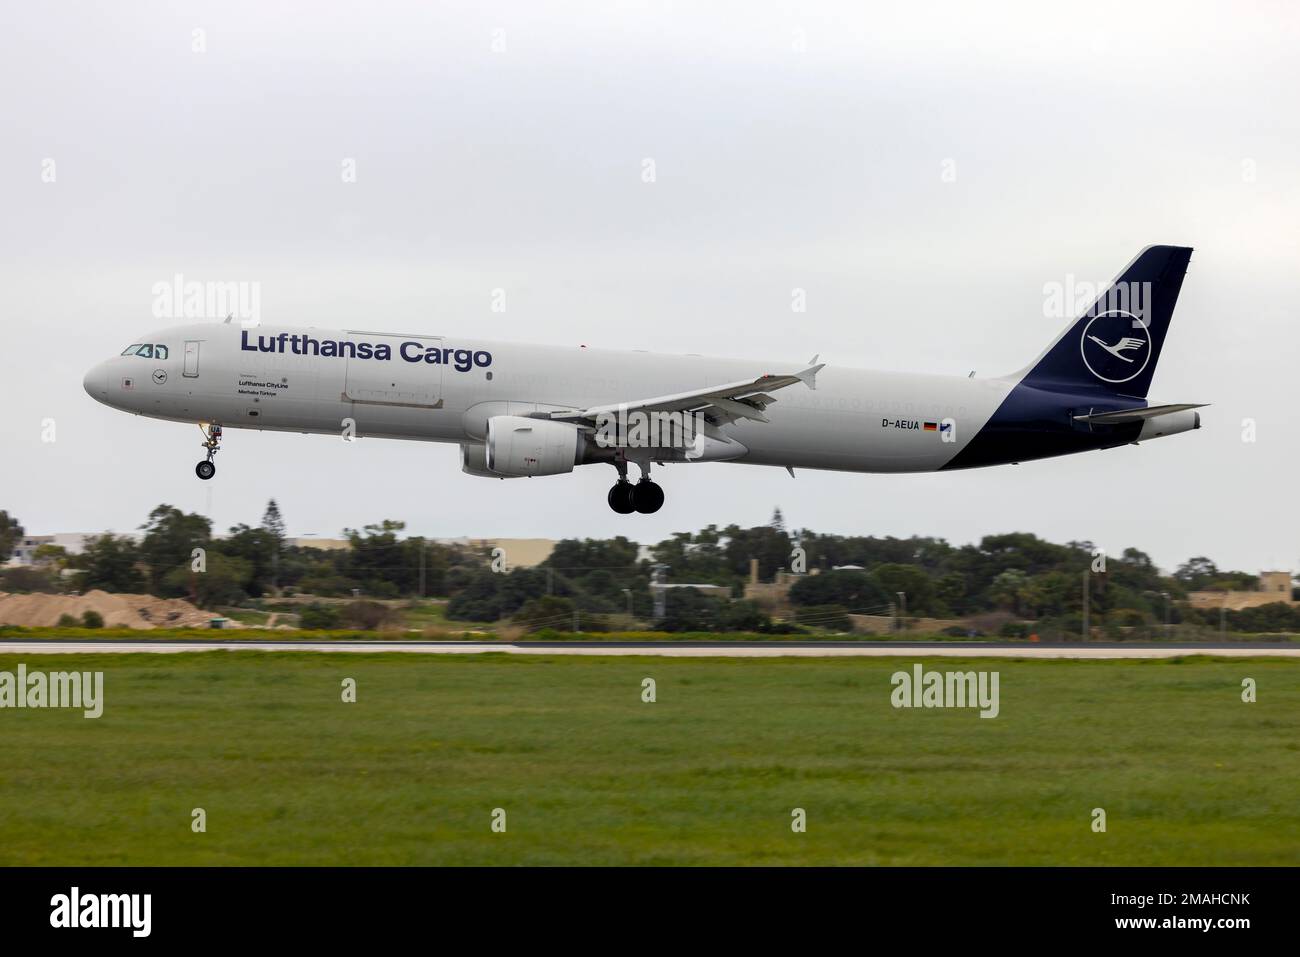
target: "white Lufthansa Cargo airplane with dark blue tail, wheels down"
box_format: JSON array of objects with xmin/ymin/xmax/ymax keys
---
[{"xmin": 85, "ymin": 246, "xmax": 1204, "ymax": 515}]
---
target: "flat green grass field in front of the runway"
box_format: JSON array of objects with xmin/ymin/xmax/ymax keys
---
[{"xmin": 0, "ymin": 651, "xmax": 1300, "ymax": 865}]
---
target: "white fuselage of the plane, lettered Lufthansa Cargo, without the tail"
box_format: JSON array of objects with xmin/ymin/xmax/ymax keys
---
[{"xmin": 86, "ymin": 324, "xmax": 1015, "ymax": 472}]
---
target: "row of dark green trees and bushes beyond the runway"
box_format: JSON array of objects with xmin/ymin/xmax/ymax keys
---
[{"xmin": 0, "ymin": 501, "xmax": 1300, "ymax": 631}]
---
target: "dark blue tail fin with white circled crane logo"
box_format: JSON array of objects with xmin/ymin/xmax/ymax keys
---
[{"xmin": 1021, "ymin": 246, "xmax": 1192, "ymax": 399}]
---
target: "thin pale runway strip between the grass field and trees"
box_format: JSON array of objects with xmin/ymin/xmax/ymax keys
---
[{"xmin": 0, "ymin": 638, "xmax": 1300, "ymax": 659}]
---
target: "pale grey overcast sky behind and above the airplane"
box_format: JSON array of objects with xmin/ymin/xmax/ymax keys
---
[{"xmin": 0, "ymin": 0, "xmax": 1300, "ymax": 571}]
